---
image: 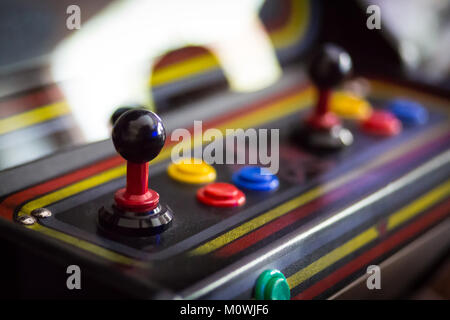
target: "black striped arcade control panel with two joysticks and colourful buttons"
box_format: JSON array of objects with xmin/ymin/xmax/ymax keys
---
[{"xmin": 0, "ymin": 1, "xmax": 450, "ymax": 300}]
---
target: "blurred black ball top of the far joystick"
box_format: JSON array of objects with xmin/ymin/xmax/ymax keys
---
[{"xmin": 309, "ymin": 43, "xmax": 352, "ymax": 89}]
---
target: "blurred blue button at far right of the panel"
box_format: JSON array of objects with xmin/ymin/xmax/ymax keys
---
[{"xmin": 388, "ymin": 99, "xmax": 428, "ymax": 126}]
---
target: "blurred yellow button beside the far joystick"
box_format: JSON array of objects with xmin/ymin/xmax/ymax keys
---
[{"xmin": 330, "ymin": 91, "xmax": 372, "ymax": 120}]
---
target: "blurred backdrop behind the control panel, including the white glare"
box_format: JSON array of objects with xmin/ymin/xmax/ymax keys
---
[{"xmin": 0, "ymin": 0, "xmax": 450, "ymax": 169}]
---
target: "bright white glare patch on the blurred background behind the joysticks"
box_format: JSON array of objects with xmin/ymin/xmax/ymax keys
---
[{"xmin": 52, "ymin": 0, "xmax": 281, "ymax": 141}]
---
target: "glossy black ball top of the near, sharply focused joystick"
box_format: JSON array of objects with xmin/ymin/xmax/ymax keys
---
[{"xmin": 112, "ymin": 109, "xmax": 166, "ymax": 163}]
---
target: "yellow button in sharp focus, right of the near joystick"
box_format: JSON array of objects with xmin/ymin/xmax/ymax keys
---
[{"xmin": 167, "ymin": 158, "xmax": 216, "ymax": 184}]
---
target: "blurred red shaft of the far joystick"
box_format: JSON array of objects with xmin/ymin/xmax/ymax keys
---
[{"xmin": 308, "ymin": 89, "xmax": 340, "ymax": 129}]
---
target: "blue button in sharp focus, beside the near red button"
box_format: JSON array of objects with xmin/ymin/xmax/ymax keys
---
[{"xmin": 233, "ymin": 166, "xmax": 280, "ymax": 191}]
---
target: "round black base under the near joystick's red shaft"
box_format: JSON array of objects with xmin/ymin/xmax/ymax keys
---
[{"xmin": 98, "ymin": 204, "xmax": 173, "ymax": 237}]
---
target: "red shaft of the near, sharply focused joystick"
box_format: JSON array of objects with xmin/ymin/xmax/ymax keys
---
[{"xmin": 114, "ymin": 161, "xmax": 159, "ymax": 212}]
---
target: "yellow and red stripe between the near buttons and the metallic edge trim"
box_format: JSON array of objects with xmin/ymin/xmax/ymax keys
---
[{"xmin": 191, "ymin": 125, "xmax": 449, "ymax": 257}]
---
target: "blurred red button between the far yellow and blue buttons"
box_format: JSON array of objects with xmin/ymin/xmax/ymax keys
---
[{"xmin": 362, "ymin": 110, "xmax": 402, "ymax": 136}]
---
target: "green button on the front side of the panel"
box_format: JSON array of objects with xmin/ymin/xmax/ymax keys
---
[{"xmin": 255, "ymin": 269, "xmax": 291, "ymax": 300}]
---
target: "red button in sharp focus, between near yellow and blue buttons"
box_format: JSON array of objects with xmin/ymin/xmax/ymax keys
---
[{"xmin": 197, "ymin": 182, "xmax": 245, "ymax": 207}]
